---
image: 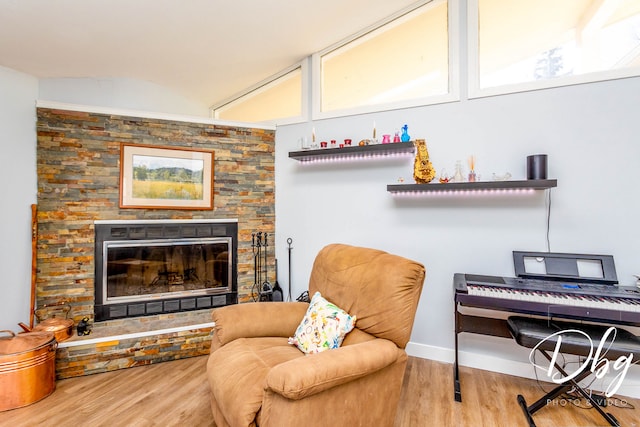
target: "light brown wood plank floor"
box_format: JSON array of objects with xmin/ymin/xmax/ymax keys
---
[{"xmin": 0, "ymin": 356, "xmax": 640, "ymax": 427}]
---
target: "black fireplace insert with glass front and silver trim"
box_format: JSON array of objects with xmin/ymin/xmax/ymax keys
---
[{"xmin": 94, "ymin": 220, "xmax": 238, "ymax": 321}]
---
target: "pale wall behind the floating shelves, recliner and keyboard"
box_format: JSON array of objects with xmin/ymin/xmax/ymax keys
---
[{"xmin": 276, "ymin": 74, "xmax": 640, "ymax": 394}]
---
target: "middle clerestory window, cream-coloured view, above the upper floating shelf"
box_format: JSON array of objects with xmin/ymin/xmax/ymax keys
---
[{"xmin": 313, "ymin": 0, "xmax": 457, "ymax": 118}]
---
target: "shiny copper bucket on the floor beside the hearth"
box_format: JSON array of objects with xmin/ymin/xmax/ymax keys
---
[{"xmin": 0, "ymin": 331, "xmax": 58, "ymax": 411}]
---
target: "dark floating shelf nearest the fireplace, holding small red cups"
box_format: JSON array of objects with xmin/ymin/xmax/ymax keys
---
[{"xmin": 289, "ymin": 141, "xmax": 415, "ymax": 162}]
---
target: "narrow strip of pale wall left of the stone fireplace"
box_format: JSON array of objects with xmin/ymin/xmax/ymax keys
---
[{"xmin": 0, "ymin": 67, "xmax": 38, "ymax": 331}]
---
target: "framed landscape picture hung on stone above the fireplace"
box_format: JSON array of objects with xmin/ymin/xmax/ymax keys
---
[{"xmin": 120, "ymin": 144, "xmax": 213, "ymax": 210}]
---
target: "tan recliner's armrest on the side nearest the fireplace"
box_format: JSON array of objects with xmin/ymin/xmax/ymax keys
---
[{"xmin": 211, "ymin": 302, "xmax": 309, "ymax": 348}]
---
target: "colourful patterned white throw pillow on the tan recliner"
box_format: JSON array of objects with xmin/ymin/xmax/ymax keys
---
[{"xmin": 289, "ymin": 292, "xmax": 356, "ymax": 354}]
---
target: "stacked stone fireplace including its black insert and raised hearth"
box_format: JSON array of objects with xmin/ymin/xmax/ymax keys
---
[{"xmin": 36, "ymin": 103, "xmax": 275, "ymax": 378}]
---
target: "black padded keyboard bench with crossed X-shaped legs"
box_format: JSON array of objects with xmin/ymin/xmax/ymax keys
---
[{"xmin": 507, "ymin": 316, "xmax": 640, "ymax": 427}]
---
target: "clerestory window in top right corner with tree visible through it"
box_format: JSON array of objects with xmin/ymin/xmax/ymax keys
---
[{"xmin": 468, "ymin": 0, "xmax": 640, "ymax": 97}]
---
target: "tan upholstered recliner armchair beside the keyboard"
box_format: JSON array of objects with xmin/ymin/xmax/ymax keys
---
[{"xmin": 207, "ymin": 244, "xmax": 425, "ymax": 427}]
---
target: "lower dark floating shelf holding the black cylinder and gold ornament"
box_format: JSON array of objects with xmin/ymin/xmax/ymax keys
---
[{"xmin": 387, "ymin": 179, "xmax": 558, "ymax": 193}]
